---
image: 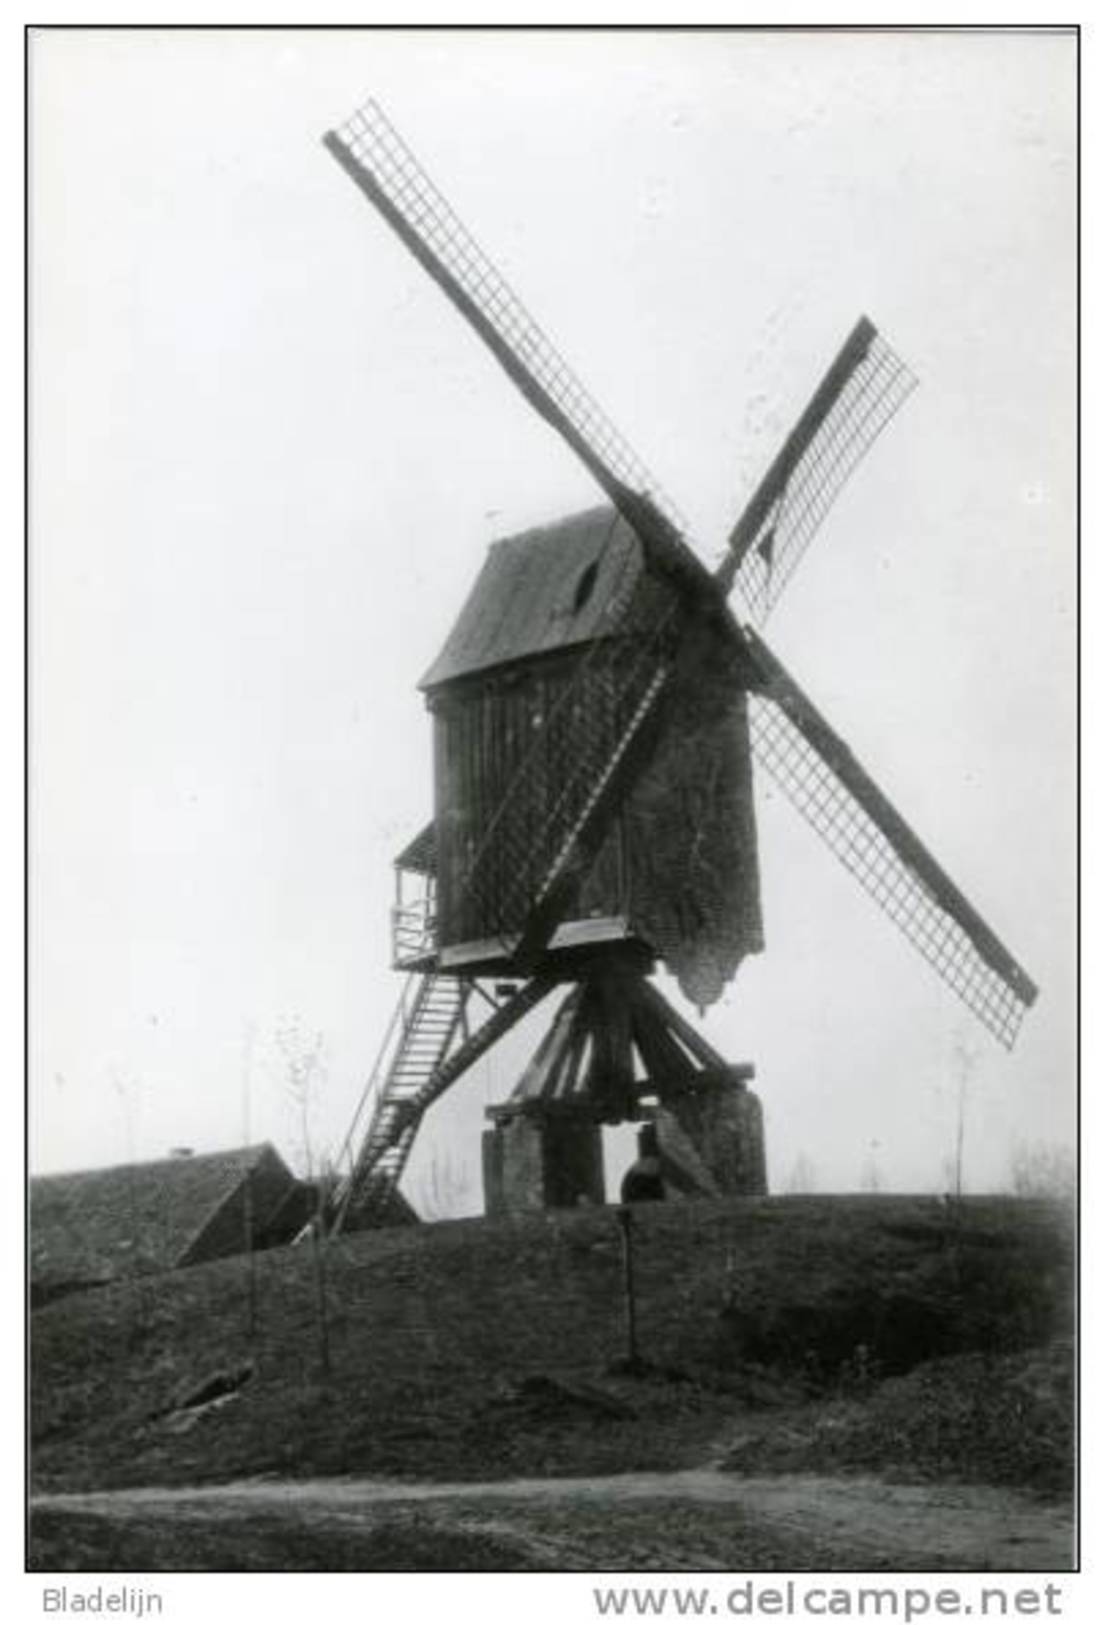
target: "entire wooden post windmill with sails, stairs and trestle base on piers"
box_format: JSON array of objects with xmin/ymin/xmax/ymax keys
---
[{"xmin": 316, "ymin": 102, "xmax": 1037, "ymax": 1227}]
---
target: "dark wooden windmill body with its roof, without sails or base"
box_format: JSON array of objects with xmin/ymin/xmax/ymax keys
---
[{"xmin": 407, "ymin": 509, "xmax": 762, "ymax": 1006}]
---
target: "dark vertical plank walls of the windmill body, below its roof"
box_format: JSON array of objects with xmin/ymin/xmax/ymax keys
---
[{"xmin": 431, "ymin": 633, "xmax": 762, "ymax": 1004}]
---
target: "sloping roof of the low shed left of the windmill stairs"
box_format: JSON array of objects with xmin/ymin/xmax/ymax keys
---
[{"xmin": 31, "ymin": 1144, "xmax": 294, "ymax": 1289}]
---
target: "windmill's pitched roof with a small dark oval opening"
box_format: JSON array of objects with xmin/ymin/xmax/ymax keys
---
[{"xmin": 419, "ymin": 507, "xmax": 665, "ymax": 689}]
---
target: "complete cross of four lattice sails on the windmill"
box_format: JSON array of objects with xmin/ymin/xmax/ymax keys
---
[{"xmin": 323, "ymin": 102, "xmax": 1035, "ymax": 1045}]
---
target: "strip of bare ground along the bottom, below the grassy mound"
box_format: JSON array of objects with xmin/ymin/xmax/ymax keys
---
[{"xmin": 33, "ymin": 1467, "xmax": 1073, "ymax": 1571}]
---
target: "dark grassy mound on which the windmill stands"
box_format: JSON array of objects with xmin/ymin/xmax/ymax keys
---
[{"xmin": 33, "ymin": 1196, "xmax": 1071, "ymax": 1489}]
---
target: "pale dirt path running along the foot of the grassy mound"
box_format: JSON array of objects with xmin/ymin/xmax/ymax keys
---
[{"xmin": 33, "ymin": 1467, "xmax": 1073, "ymax": 1571}]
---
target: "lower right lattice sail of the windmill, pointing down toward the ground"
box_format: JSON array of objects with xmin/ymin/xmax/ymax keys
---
[{"xmin": 746, "ymin": 632, "xmax": 1037, "ymax": 1048}]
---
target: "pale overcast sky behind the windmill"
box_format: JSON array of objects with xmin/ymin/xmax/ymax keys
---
[{"xmin": 31, "ymin": 31, "xmax": 1076, "ymax": 1207}]
